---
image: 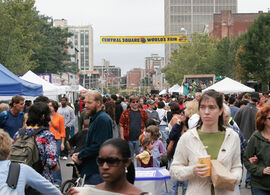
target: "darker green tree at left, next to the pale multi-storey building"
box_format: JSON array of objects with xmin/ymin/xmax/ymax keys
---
[{"xmin": 31, "ymin": 16, "xmax": 76, "ymax": 73}]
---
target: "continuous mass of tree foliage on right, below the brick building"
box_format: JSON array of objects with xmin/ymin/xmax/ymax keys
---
[{"xmin": 162, "ymin": 13, "xmax": 270, "ymax": 91}]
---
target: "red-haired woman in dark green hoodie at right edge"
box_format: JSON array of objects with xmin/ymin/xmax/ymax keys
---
[{"xmin": 244, "ymin": 104, "xmax": 270, "ymax": 195}]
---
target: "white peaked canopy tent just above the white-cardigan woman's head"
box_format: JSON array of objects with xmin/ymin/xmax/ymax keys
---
[{"xmin": 202, "ymin": 77, "xmax": 255, "ymax": 94}]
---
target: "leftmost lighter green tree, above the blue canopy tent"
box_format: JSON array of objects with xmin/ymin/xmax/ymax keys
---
[{"xmin": 0, "ymin": 0, "xmax": 40, "ymax": 74}]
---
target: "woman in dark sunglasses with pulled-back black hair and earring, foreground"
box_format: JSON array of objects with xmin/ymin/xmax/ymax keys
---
[{"xmin": 69, "ymin": 138, "xmax": 148, "ymax": 195}]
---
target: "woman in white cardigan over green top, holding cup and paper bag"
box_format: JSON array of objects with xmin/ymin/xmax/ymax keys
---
[{"xmin": 170, "ymin": 90, "xmax": 242, "ymax": 195}]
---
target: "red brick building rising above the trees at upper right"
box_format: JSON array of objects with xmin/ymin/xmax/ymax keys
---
[{"xmin": 209, "ymin": 10, "xmax": 261, "ymax": 39}]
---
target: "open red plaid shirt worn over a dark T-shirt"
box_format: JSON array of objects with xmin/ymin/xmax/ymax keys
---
[{"xmin": 119, "ymin": 108, "xmax": 148, "ymax": 141}]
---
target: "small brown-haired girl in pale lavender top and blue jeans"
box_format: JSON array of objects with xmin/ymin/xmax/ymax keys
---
[{"xmin": 146, "ymin": 125, "xmax": 165, "ymax": 167}]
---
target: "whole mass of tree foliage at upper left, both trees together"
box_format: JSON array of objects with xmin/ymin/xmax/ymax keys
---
[{"xmin": 0, "ymin": 0, "xmax": 76, "ymax": 74}]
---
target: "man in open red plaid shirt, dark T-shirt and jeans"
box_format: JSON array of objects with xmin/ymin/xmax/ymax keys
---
[{"xmin": 119, "ymin": 95, "xmax": 148, "ymax": 162}]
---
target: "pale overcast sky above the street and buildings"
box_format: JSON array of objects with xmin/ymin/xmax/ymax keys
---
[{"xmin": 36, "ymin": 0, "xmax": 270, "ymax": 74}]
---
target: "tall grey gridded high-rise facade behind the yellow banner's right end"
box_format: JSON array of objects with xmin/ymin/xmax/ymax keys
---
[{"xmin": 164, "ymin": 0, "xmax": 237, "ymax": 65}]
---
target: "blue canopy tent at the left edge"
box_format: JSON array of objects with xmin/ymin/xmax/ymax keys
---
[{"xmin": 0, "ymin": 64, "xmax": 43, "ymax": 97}]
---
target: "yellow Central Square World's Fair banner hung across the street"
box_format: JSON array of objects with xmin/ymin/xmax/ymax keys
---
[{"xmin": 100, "ymin": 35, "xmax": 188, "ymax": 44}]
